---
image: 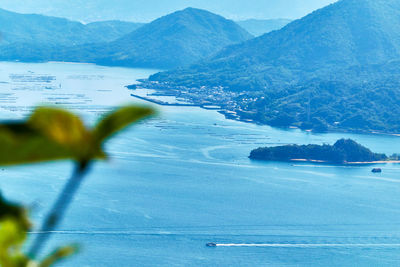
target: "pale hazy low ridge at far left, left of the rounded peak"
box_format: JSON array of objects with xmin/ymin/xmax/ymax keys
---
[{"xmin": 0, "ymin": 9, "xmax": 141, "ymax": 46}]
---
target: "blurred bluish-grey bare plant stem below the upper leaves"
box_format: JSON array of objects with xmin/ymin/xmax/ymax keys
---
[{"xmin": 28, "ymin": 162, "xmax": 91, "ymax": 259}]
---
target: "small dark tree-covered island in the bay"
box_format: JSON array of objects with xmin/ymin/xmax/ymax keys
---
[{"xmin": 249, "ymin": 139, "xmax": 399, "ymax": 164}]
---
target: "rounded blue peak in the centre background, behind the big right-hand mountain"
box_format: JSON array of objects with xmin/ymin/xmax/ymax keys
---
[{"xmin": 84, "ymin": 8, "xmax": 253, "ymax": 68}]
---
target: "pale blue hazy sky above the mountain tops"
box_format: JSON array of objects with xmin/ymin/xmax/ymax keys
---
[{"xmin": 0, "ymin": 0, "xmax": 336, "ymax": 22}]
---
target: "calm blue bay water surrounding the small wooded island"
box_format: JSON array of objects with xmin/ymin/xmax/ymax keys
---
[{"xmin": 0, "ymin": 63, "xmax": 400, "ymax": 266}]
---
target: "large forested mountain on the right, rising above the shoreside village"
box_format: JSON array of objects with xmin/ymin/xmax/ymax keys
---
[{"xmin": 150, "ymin": 0, "xmax": 400, "ymax": 132}]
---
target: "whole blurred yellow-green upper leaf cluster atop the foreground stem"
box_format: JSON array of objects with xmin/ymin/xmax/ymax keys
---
[{"xmin": 0, "ymin": 106, "xmax": 154, "ymax": 165}]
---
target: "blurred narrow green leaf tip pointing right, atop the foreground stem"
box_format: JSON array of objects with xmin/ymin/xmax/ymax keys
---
[{"xmin": 93, "ymin": 106, "xmax": 155, "ymax": 146}]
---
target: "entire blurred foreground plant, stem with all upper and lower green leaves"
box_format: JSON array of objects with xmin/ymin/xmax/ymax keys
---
[{"xmin": 0, "ymin": 105, "xmax": 155, "ymax": 267}]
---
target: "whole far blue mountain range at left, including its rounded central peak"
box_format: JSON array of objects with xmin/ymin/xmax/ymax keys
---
[{"xmin": 0, "ymin": 8, "xmax": 253, "ymax": 69}]
